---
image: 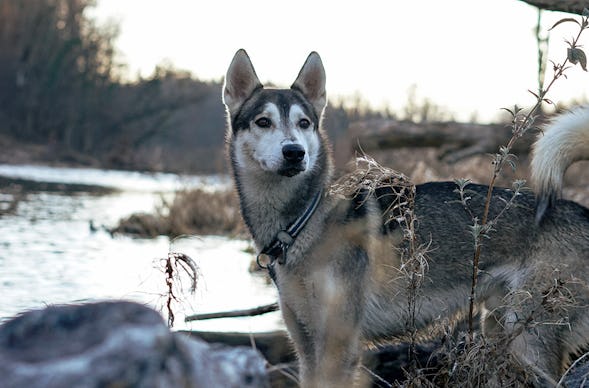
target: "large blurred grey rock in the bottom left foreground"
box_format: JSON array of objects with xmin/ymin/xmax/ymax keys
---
[{"xmin": 0, "ymin": 301, "xmax": 268, "ymax": 388}]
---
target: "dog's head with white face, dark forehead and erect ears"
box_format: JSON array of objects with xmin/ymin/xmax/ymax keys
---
[{"xmin": 223, "ymin": 50, "xmax": 327, "ymax": 177}]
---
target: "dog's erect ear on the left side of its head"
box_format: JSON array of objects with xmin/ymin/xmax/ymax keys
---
[{"xmin": 223, "ymin": 49, "xmax": 262, "ymax": 112}]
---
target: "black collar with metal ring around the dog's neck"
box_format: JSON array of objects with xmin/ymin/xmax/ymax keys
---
[{"xmin": 256, "ymin": 190, "xmax": 323, "ymax": 270}]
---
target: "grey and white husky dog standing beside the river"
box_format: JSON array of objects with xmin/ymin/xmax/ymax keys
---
[{"xmin": 223, "ymin": 50, "xmax": 589, "ymax": 387}]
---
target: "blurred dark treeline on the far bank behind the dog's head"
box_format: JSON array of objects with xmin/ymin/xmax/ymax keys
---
[{"xmin": 0, "ymin": 0, "xmax": 448, "ymax": 172}]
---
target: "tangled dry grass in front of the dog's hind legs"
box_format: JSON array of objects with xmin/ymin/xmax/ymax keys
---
[{"xmin": 428, "ymin": 265, "xmax": 586, "ymax": 387}]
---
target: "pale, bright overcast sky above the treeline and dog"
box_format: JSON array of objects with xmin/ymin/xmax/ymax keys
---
[{"xmin": 90, "ymin": 0, "xmax": 589, "ymax": 122}]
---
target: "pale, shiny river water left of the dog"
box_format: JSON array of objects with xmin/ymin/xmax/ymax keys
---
[{"xmin": 0, "ymin": 165, "xmax": 282, "ymax": 331}]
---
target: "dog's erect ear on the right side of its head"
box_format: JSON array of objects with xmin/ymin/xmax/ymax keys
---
[{"xmin": 291, "ymin": 51, "xmax": 327, "ymax": 115}]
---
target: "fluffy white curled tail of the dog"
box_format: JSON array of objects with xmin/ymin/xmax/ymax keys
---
[{"xmin": 531, "ymin": 106, "xmax": 589, "ymax": 223}]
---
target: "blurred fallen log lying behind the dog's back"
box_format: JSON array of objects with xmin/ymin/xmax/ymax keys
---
[{"xmin": 349, "ymin": 119, "xmax": 534, "ymax": 163}]
